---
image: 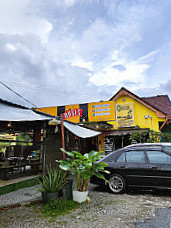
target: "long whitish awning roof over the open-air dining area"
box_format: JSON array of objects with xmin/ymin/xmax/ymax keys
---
[{"xmin": 0, "ymin": 103, "xmax": 52, "ymax": 121}]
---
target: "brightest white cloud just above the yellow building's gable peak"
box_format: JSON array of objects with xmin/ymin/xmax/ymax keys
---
[{"xmin": 90, "ymin": 51, "xmax": 158, "ymax": 87}]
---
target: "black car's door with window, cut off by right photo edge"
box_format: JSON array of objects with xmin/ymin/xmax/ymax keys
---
[{"xmin": 146, "ymin": 149, "xmax": 171, "ymax": 188}]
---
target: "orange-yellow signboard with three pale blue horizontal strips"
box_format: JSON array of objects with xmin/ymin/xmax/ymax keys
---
[{"xmin": 88, "ymin": 101, "xmax": 115, "ymax": 122}]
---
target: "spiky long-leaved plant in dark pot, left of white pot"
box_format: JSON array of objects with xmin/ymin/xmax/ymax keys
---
[{"xmin": 39, "ymin": 168, "xmax": 66, "ymax": 204}]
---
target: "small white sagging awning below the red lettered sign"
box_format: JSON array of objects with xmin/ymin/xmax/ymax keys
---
[{"xmin": 64, "ymin": 121, "xmax": 101, "ymax": 138}]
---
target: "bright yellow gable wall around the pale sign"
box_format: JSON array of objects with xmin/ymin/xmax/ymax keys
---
[{"xmin": 108, "ymin": 95, "xmax": 165, "ymax": 132}]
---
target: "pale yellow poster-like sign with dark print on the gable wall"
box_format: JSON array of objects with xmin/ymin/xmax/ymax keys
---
[{"xmin": 116, "ymin": 103, "xmax": 135, "ymax": 127}]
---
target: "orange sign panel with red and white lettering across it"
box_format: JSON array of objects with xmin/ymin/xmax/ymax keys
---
[{"xmin": 64, "ymin": 104, "xmax": 82, "ymax": 123}]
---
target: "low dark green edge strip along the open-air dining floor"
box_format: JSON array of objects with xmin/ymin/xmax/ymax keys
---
[{"xmin": 0, "ymin": 177, "xmax": 39, "ymax": 195}]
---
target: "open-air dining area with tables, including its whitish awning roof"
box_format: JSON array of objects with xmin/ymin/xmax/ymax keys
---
[{"xmin": 0, "ymin": 100, "xmax": 50, "ymax": 183}]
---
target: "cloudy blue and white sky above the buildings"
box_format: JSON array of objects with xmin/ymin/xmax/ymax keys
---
[{"xmin": 0, "ymin": 0, "xmax": 171, "ymax": 107}]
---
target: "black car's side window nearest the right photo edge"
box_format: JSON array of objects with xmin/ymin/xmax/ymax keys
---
[{"xmin": 147, "ymin": 150, "xmax": 171, "ymax": 164}]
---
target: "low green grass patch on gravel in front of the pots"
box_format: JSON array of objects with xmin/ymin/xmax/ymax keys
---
[{"xmin": 43, "ymin": 198, "xmax": 80, "ymax": 217}]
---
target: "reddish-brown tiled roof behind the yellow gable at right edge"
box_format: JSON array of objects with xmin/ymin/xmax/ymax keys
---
[{"xmin": 141, "ymin": 95, "xmax": 171, "ymax": 119}]
